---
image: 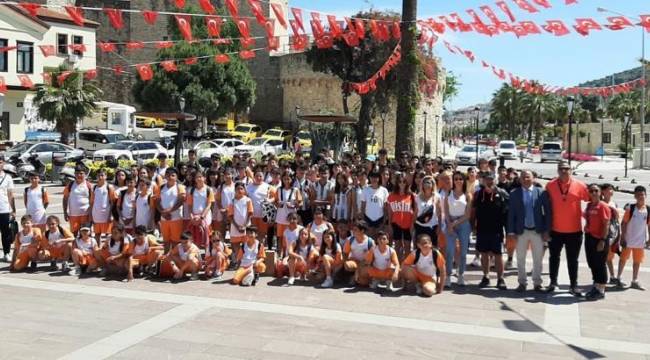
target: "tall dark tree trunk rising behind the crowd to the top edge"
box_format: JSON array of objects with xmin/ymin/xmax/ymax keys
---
[{"xmin": 395, "ymin": 0, "xmax": 419, "ymax": 154}]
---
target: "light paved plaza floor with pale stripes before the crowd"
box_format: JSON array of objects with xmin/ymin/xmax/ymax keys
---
[{"xmin": 0, "ymin": 185, "xmax": 650, "ymax": 359}]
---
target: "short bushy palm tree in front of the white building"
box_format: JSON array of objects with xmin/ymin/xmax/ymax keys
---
[{"xmin": 34, "ymin": 65, "xmax": 102, "ymax": 143}]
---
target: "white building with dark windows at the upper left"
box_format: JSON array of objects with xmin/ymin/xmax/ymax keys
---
[{"xmin": 0, "ymin": 4, "xmax": 99, "ymax": 141}]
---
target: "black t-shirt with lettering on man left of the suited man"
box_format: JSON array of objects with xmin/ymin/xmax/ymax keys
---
[{"xmin": 472, "ymin": 188, "xmax": 508, "ymax": 234}]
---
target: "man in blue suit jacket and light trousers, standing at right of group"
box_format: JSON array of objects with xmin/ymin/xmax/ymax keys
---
[{"xmin": 507, "ymin": 170, "xmax": 551, "ymax": 292}]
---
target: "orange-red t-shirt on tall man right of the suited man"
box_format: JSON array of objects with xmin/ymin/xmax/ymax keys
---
[{"xmin": 546, "ymin": 178, "xmax": 589, "ymax": 233}]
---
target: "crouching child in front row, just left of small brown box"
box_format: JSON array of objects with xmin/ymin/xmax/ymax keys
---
[{"xmin": 232, "ymin": 226, "xmax": 266, "ymax": 286}]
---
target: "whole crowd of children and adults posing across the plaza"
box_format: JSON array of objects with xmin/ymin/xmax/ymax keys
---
[{"xmin": 0, "ymin": 150, "xmax": 650, "ymax": 300}]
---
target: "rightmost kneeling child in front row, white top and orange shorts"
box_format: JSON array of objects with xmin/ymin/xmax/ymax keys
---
[{"xmin": 402, "ymin": 234, "xmax": 446, "ymax": 297}]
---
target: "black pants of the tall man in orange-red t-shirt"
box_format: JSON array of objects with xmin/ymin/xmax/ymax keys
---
[{"xmin": 548, "ymin": 232, "xmax": 582, "ymax": 287}]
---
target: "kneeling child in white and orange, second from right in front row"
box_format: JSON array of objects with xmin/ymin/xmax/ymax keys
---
[{"xmin": 366, "ymin": 231, "xmax": 399, "ymax": 291}]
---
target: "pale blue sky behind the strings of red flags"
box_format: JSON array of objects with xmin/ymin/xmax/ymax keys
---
[{"xmin": 290, "ymin": 0, "xmax": 650, "ymax": 109}]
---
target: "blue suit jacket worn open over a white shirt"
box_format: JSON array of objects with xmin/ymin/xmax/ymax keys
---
[{"xmin": 506, "ymin": 186, "xmax": 552, "ymax": 235}]
